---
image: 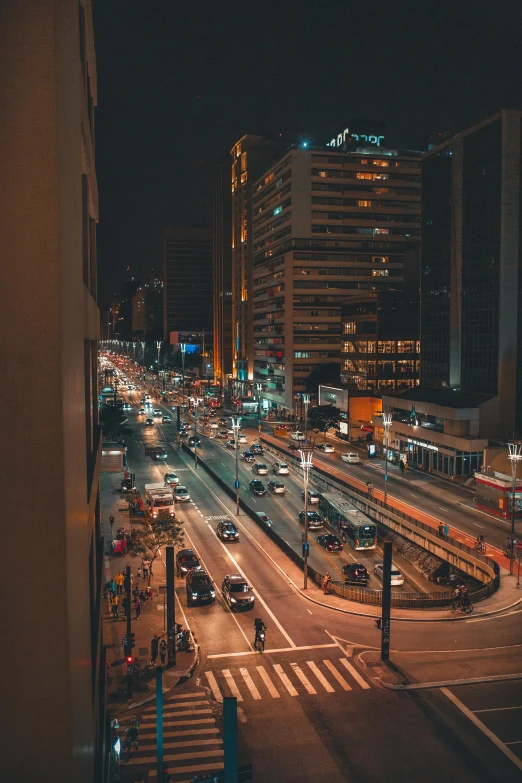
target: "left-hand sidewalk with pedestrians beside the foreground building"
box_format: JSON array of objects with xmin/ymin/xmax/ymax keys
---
[{"xmin": 100, "ymin": 473, "xmax": 199, "ymax": 714}]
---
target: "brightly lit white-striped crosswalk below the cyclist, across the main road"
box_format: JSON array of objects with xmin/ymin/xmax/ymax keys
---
[{"xmin": 204, "ymin": 658, "xmax": 371, "ymax": 702}]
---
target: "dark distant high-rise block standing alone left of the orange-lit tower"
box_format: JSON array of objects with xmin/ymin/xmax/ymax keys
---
[{"xmin": 163, "ymin": 228, "xmax": 212, "ymax": 338}]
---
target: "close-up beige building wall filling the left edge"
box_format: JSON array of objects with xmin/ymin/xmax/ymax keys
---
[{"xmin": 0, "ymin": 0, "xmax": 109, "ymax": 783}]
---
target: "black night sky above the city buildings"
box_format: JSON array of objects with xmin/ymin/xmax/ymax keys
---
[{"xmin": 93, "ymin": 0, "xmax": 522, "ymax": 305}]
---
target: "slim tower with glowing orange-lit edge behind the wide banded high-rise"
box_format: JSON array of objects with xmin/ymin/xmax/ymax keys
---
[{"xmin": 230, "ymin": 135, "xmax": 288, "ymax": 394}]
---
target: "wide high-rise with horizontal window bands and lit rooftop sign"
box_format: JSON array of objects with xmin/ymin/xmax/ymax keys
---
[{"xmin": 252, "ymin": 134, "xmax": 421, "ymax": 410}]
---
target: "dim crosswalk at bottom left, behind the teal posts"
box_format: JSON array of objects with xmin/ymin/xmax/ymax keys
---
[{"xmin": 120, "ymin": 691, "xmax": 224, "ymax": 783}]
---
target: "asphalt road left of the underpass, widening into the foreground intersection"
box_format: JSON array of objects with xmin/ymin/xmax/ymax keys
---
[{"xmin": 106, "ymin": 364, "xmax": 522, "ymax": 783}]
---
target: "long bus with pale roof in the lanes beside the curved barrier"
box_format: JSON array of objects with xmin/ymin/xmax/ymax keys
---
[{"xmin": 319, "ymin": 492, "xmax": 377, "ymax": 550}]
